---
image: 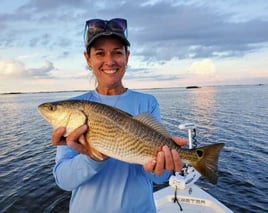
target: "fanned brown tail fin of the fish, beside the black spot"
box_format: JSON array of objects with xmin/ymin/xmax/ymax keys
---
[{"xmin": 191, "ymin": 143, "xmax": 224, "ymax": 184}]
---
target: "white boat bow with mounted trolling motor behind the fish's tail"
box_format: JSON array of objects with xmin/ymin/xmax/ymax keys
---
[{"xmin": 154, "ymin": 123, "xmax": 233, "ymax": 213}]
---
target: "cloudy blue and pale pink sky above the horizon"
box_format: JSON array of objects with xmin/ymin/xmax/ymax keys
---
[{"xmin": 0, "ymin": 0, "xmax": 268, "ymax": 93}]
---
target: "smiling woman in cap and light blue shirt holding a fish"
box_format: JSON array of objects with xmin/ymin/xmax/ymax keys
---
[{"xmin": 52, "ymin": 19, "xmax": 185, "ymax": 213}]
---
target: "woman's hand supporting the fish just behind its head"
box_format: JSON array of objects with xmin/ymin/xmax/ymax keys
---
[{"xmin": 51, "ymin": 125, "xmax": 107, "ymax": 161}]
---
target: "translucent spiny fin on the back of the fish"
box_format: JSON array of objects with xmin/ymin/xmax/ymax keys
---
[{"xmin": 133, "ymin": 113, "xmax": 171, "ymax": 138}]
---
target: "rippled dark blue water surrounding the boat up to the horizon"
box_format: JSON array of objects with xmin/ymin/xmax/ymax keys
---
[{"xmin": 0, "ymin": 85, "xmax": 268, "ymax": 212}]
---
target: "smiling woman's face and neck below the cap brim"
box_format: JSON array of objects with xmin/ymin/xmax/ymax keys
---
[{"xmin": 84, "ymin": 36, "xmax": 129, "ymax": 89}]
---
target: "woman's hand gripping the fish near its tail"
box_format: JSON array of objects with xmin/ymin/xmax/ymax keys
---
[{"xmin": 143, "ymin": 137, "xmax": 187, "ymax": 175}]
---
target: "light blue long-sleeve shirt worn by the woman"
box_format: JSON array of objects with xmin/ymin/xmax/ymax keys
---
[{"xmin": 53, "ymin": 90, "xmax": 170, "ymax": 213}]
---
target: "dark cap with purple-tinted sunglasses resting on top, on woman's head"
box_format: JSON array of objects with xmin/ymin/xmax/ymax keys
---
[{"xmin": 84, "ymin": 18, "xmax": 130, "ymax": 50}]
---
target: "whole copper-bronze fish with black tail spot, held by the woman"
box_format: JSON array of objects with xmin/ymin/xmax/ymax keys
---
[{"xmin": 38, "ymin": 100, "xmax": 224, "ymax": 184}]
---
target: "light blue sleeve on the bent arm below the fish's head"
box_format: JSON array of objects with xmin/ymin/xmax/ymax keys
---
[{"xmin": 53, "ymin": 146, "xmax": 105, "ymax": 191}]
